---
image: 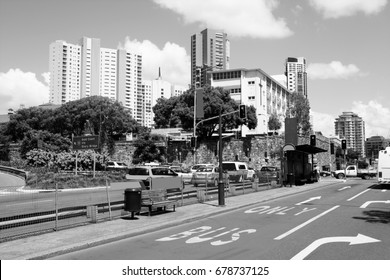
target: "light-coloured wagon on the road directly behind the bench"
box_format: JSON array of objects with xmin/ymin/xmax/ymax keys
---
[{"xmin": 126, "ymin": 165, "xmax": 179, "ymax": 188}]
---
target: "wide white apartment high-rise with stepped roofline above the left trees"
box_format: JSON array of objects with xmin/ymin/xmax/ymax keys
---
[{"xmin": 49, "ymin": 37, "xmax": 145, "ymax": 123}]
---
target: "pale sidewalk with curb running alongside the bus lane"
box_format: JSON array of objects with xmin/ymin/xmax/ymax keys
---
[{"xmin": 0, "ymin": 181, "xmax": 339, "ymax": 260}]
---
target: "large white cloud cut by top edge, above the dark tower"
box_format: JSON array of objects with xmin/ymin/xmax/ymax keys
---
[{"xmin": 154, "ymin": 0, "xmax": 292, "ymax": 38}]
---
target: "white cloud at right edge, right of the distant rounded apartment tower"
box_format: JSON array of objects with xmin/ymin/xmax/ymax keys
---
[{"xmin": 351, "ymin": 100, "xmax": 390, "ymax": 138}]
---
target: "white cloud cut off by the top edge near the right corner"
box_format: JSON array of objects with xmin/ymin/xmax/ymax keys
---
[{"xmin": 309, "ymin": 0, "xmax": 387, "ymax": 18}]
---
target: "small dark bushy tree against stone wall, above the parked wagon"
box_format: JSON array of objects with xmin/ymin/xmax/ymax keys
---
[{"xmin": 133, "ymin": 129, "xmax": 166, "ymax": 164}]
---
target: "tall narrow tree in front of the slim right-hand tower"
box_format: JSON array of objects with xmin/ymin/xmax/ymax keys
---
[{"xmin": 287, "ymin": 93, "xmax": 312, "ymax": 136}]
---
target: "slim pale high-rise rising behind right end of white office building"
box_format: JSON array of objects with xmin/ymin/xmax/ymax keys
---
[{"xmin": 285, "ymin": 57, "xmax": 307, "ymax": 98}]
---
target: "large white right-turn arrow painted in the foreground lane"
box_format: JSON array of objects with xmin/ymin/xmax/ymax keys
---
[{"xmin": 292, "ymin": 233, "xmax": 380, "ymax": 260}]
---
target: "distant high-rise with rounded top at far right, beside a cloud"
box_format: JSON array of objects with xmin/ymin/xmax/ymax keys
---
[{"xmin": 335, "ymin": 112, "xmax": 366, "ymax": 157}]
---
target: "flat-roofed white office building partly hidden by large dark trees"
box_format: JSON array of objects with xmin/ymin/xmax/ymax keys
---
[{"xmin": 211, "ymin": 69, "xmax": 290, "ymax": 136}]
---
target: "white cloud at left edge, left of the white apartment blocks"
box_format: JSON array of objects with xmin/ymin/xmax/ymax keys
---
[{"xmin": 0, "ymin": 69, "xmax": 49, "ymax": 114}]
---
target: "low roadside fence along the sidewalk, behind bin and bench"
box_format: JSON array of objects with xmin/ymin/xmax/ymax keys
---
[{"xmin": 0, "ymin": 176, "xmax": 280, "ymax": 242}]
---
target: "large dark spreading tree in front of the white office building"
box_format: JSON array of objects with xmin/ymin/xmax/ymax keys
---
[{"xmin": 153, "ymin": 85, "xmax": 257, "ymax": 138}]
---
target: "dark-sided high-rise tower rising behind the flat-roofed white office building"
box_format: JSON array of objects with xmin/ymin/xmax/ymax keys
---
[{"xmin": 191, "ymin": 29, "xmax": 230, "ymax": 87}]
